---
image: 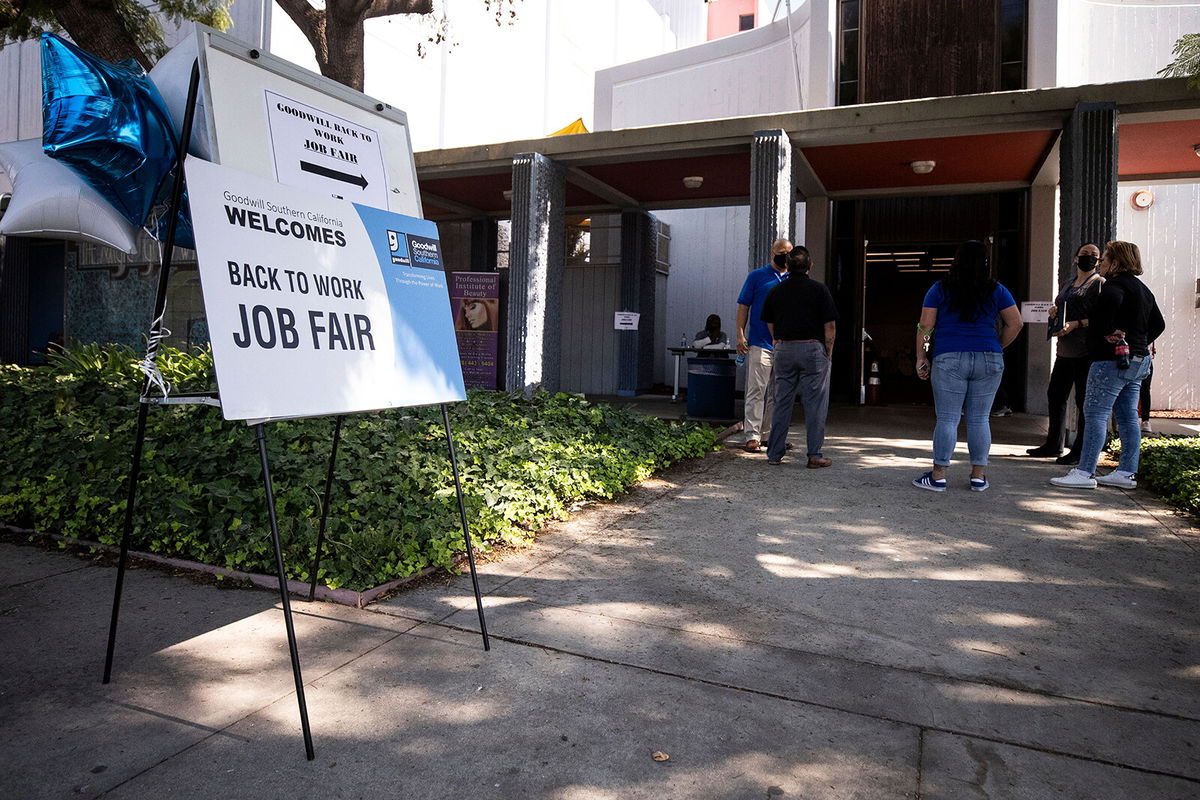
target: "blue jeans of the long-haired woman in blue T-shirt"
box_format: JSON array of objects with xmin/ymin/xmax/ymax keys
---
[{"xmin": 930, "ymin": 353, "xmax": 1004, "ymax": 467}]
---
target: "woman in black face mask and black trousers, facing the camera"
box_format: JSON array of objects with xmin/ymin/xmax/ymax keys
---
[{"xmin": 1026, "ymin": 245, "xmax": 1104, "ymax": 464}]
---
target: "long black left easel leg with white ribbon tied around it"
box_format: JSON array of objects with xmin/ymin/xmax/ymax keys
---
[{"xmin": 103, "ymin": 61, "xmax": 200, "ymax": 684}]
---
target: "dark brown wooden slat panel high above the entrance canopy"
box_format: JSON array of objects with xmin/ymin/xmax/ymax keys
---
[{"xmin": 860, "ymin": 0, "xmax": 1000, "ymax": 103}]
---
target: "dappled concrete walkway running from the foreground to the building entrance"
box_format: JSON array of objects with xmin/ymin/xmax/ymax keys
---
[{"xmin": 0, "ymin": 409, "xmax": 1200, "ymax": 800}]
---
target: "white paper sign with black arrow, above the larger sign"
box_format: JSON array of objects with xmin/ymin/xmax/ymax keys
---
[{"xmin": 263, "ymin": 89, "xmax": 388, "ymax": 209}]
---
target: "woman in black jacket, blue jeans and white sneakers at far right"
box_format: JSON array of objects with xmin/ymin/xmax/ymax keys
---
[{"xmin": 1050, "ymin": 241, "xmax": 1166, "ymax": 489}]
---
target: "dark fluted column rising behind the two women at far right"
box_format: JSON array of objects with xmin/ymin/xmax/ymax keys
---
[{"xmin": 1058, "ymin": 103, "xmax": 1117, "ymax": 284}]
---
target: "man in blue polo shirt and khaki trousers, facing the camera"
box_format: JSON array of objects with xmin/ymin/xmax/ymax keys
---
[{"xmin": 737, "ymin": 239, "xmax": 792, "ymax": 452}]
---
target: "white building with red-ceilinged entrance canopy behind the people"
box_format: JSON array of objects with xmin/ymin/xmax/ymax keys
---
[{"xmin": 0, "ymin": 0, "xmax": 1200, "ymax": 411}]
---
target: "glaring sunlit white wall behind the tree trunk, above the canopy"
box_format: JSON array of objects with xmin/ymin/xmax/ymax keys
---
[{"xmin": 271, "ymin": 0, "xmax": 703, "ymax": 150}]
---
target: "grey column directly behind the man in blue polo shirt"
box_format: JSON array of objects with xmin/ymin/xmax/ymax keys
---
[{"xmin": 748, "ymin": 131, "xmax": 796, "ymax": 270}]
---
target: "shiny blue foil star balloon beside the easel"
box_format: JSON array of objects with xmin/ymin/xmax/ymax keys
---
[{"xmin": 42, "ymin": 34, "xmax": 194, "ymax": 247}]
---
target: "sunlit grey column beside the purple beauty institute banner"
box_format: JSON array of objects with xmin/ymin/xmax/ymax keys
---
[{"xmin": 504, "ymin": 152, "xmax": 566, "ymax": 395}]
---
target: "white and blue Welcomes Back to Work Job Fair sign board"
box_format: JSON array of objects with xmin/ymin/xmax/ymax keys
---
[{"xmin": 186, "ymin": 157, "xmax": 466, "ymax": 421}]
